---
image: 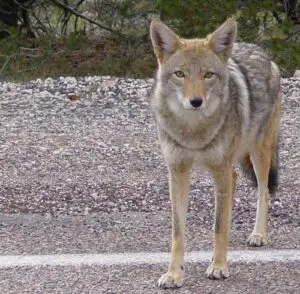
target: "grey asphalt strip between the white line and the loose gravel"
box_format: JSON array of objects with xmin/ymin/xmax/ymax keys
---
[{"xmin": 0, "ymin": 211, "xmax": 300, "ymax": 255}]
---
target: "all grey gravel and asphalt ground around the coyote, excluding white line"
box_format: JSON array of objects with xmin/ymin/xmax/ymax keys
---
[{"xmin": 0, "ymin": 77, "xmax": 300, "ymax": 294}]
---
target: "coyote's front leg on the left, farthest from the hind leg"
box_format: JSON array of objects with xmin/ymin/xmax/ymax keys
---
[{"xmin": 158, "ymin": 163, "xmax": 191, "ymax": 288}]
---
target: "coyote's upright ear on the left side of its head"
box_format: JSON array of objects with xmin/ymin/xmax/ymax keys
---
[{"xmin": 150, "ymin": 19, "xmax": 179, "ymax": 64}]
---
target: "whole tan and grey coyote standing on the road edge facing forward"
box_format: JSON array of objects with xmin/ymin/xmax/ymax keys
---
[{"xmin": 150, "ymin": 18, "xmax": 281, "ymax": 288}]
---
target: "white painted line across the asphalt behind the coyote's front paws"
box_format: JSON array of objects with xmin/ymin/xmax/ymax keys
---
[{"xmin": 0, "ymin": 249, "xmax": 300, "ymax": 268}]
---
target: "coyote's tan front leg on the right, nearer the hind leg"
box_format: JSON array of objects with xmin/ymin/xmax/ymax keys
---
[{"xmin": 206, "ymin": 165, "xmax": 236, "ymax": 279}]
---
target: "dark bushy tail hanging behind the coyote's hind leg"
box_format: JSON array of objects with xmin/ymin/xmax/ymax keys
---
[{"xmin": 240, "ymin": 145, "xmax": 279, "ymax": 194}]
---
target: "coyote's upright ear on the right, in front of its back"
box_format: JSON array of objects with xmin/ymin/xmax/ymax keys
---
[{"xmin": 208, "ymin": 18, "xmax": 237, "ymax": 60}]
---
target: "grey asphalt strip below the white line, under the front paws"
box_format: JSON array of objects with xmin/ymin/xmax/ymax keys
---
[{"xmin": 0, "ymin": 263, "xmax": 300, "ymax": 294}]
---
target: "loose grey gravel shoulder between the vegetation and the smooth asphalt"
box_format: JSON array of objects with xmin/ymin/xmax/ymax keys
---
[{"xmin": 0, "ymin": 77, "xmax": 300, "ymax": 227}]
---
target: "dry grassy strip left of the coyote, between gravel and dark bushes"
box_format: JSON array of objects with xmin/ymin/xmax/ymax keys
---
[{"xmin": 0, "ymin": 32, "xmax": 156, "ymax": 82}]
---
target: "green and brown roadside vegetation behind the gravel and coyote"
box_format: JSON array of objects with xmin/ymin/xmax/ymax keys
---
[{"xmin": 0, "ymin": 0, "xmax": 300, "ymax": 81}]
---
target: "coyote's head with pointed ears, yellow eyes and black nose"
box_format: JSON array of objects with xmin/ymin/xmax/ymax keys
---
[{"xmin": 150, "ymin": 19, "xmax": 237, "ymax": 110}]
